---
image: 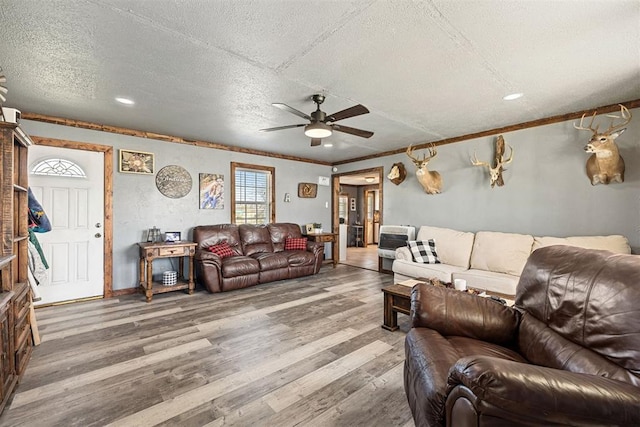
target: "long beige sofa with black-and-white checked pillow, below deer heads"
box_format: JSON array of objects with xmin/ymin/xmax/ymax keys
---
[{"xmin": 392, "ymin": 226, "xmax": 631, "ymax": 295}]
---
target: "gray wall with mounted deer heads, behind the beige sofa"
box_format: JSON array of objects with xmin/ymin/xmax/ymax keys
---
[{"xmin": 338, "ymin": 109, "xmax": 640, "ymax": 253}]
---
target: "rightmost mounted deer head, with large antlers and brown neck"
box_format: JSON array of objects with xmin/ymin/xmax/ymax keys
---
[{"xmin": 573, "ymin": 104, "xmax": 631, "ymax": 185}]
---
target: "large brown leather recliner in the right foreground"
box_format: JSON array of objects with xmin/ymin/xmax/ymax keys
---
[{"xmin": 404, "ymin": 246, "xmax": 640, "ymax": 426}]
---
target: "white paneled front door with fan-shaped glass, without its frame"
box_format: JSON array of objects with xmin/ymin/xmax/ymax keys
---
[{"xmin": 29, "ymin": 145, "xmax": 104, "ymax": 305}]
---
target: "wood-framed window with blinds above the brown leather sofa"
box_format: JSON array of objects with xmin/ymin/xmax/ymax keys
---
[{"xmin": 231, "ymin": 163, "xmax": 275, "ymax": 224}]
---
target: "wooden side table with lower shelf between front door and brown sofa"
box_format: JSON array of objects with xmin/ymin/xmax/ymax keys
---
[{"xmin": 138, "ymin": 241, "xmax": 198, "ymax": 302}]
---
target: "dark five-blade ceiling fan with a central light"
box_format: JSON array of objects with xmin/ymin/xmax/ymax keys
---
[{"xmin": 260, "ymin": 94, "xmax": 373, "ymax": 147}]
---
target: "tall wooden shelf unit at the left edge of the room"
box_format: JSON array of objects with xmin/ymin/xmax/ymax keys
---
[{"xmin": 0, "ymin": 122, "xmax": 33, "ymax": 412}]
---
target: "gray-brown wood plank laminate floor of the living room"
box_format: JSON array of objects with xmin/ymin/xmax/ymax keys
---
[{"xmin": 0, "ymin": 265, "xmax": 413, "ymax": 427}]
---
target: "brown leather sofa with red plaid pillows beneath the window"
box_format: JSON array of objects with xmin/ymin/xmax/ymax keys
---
[{"xmin": 193, "ymin": 223, "xmax": 324, "ymax": 292}]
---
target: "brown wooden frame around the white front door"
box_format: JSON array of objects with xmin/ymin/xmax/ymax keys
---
[{"xmin": 31, "ymin": 136, "xmax": 115, "ymax": 298}]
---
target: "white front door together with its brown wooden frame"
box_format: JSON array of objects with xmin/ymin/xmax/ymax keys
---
[{"xmin": 28, "ymin": 137, "xmax": 113, "ymax": 306}]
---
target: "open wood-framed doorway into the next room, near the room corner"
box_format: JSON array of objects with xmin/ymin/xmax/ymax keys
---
[{"xmin": 332, "ymin": 167, "xmax": 384, "ymax": 271}]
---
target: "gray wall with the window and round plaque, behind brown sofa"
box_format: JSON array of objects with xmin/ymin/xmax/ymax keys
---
[{"xmin": 21, "ymin": 121, "xmax": 331, "ymax": 290}]
